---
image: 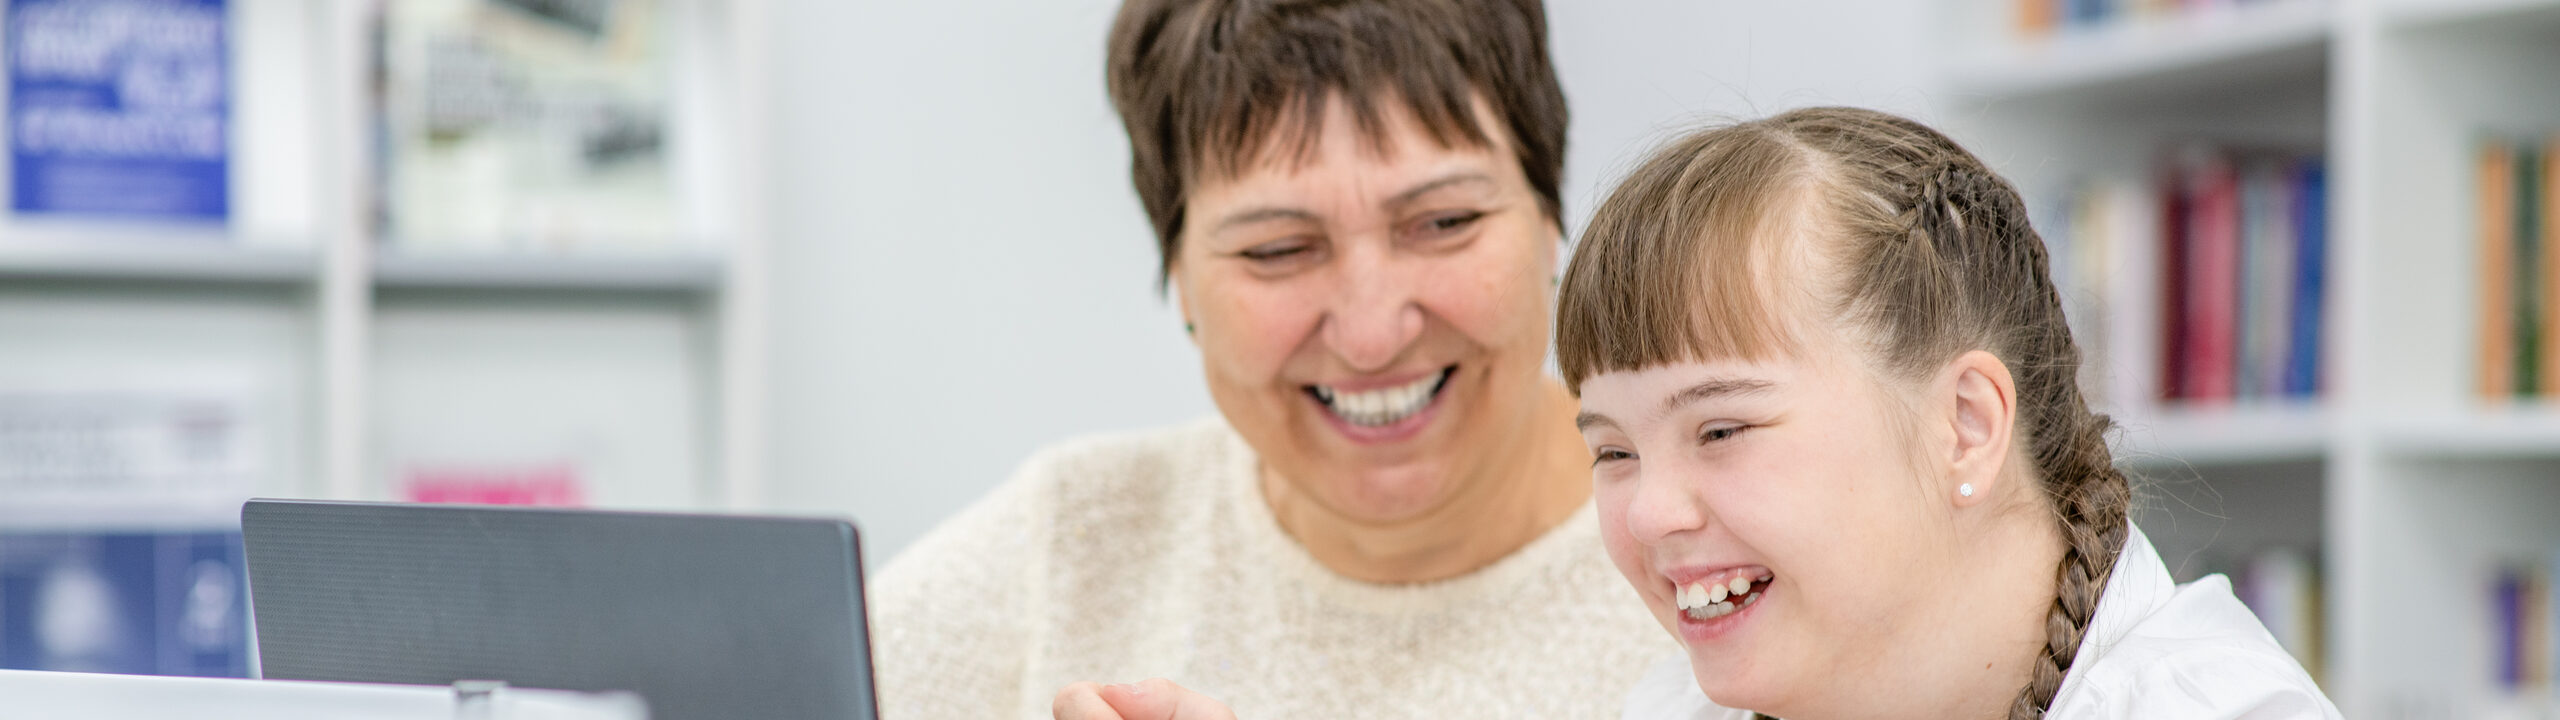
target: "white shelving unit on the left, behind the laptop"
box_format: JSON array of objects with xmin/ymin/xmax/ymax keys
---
[{"xmin": 0, "ymin": 0, "xmax": 765, "ymax": 510}]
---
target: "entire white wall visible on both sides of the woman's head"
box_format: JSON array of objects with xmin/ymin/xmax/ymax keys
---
[{"xmin": 768, "ymin": 0, "xmax": 1930, "ymax": 566}]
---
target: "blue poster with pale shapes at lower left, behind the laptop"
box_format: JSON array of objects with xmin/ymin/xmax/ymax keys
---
[{"xmin": 0, "ymin": 530, "xmax": 251, "ymax": 676}]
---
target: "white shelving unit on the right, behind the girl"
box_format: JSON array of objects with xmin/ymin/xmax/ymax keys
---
[{"xmin": 1943, "ymin": 0, "xmax": 2560, "ymax": 717}]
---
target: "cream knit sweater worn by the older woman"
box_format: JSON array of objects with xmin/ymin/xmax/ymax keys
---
[{"xmin": 870, "ymin": 418, "xmax": 1677, "ymax": 720}]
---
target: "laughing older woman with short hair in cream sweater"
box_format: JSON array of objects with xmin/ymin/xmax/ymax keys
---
[{"xmin": 873, "ymin": 0, "xmax": 1672, "ymax": 720}]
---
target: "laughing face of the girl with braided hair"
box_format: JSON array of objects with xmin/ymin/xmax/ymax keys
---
[{"xmin": 1580, "ymin": 333, "xmax": 1966, "ymax": 712}]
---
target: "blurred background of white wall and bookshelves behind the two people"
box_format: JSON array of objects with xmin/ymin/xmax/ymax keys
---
[{"xmin": 0, "ymin": 0, "xmax": 2560, "ymax": 717}]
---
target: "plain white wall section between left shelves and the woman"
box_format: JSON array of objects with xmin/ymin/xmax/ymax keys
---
[{"xmin": 768, "ymin": 0, "xmax": 1208, "ymax": 566}]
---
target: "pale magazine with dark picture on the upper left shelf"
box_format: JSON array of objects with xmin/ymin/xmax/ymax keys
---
[{"xmin": 376, "ymin": 0, "xmax": 694, "ymax": 254}]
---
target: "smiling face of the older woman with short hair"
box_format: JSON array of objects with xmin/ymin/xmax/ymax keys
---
[{"xmin": 1172, "ymin": 92, "xmax": 1559, "ymax": 523}]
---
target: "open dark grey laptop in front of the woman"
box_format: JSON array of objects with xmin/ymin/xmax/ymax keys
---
[{"xmin": 241, "ymin": 500, "xmax": 878, "ymax": 720}]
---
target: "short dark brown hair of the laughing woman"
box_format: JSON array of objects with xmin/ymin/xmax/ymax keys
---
[{"xmin": 1108, "ymin": 0, "xmax": 1564, "ymax": 279}]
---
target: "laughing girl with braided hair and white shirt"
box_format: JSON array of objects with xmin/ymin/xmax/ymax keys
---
[{"xmin": 1556, "ymin": 108, "xmax": 2337, "ymax": 720}]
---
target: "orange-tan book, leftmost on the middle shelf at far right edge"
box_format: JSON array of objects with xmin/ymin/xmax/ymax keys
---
[{"xmin": 2473, "ymin": 138, "xmax": 2516, "ymax": 400}]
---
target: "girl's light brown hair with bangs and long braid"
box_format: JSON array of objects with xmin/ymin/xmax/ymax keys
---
[{"xmin": 1556, "ymin": 108, "xmax": 2132, "ymax": 717}]
